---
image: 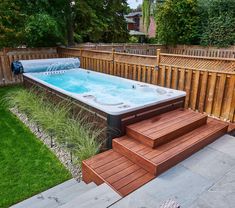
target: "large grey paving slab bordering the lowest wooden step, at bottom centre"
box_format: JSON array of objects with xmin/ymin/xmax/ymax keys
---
[{"xmin": 111, "ymin": 165, "xmax": 212, "ymax": 208}]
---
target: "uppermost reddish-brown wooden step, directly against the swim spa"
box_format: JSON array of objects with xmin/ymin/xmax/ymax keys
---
[{"xmin": 126, "ymin": 109, "xmax": 207, "ymax": 147}]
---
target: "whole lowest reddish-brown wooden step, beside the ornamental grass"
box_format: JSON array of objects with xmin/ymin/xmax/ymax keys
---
[{"xmin": 82, "ymin": 150, "xmax": 155, "ymax": 196}]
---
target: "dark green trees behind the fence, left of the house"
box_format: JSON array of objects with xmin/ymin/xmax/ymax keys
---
[{"xmin": 0, "ymin": 0, "xmax": 129, "ymax": 47}]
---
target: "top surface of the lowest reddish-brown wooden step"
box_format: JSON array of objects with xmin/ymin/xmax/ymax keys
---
[{"xmin": 83, "ymin": 150, "xmax": 154, "ymax": 196}]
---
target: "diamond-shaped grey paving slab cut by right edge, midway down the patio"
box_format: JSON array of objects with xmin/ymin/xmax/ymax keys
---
[{"xmin": 180, "ymin": 147, "xmax": 235, "ymax": 182}]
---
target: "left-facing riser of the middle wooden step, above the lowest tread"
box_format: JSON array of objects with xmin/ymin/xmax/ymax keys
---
[{"xmin": 113, "ymin": 139, "xmax": 157, "ymax": 175}]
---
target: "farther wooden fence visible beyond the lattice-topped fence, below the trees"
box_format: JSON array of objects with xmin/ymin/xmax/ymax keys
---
[{"xmin": 78, "ymin": 44, "xmax": 235, "ymax": 59}]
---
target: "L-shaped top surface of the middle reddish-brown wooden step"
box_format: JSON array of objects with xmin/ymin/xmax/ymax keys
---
[{"xmin": 113, "ymin": 119, "xmax": 228, "ymax": 174}]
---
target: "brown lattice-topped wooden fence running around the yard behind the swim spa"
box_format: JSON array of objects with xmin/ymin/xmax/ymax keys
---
[{"xmin": 0, "ymin": 48, "xmax": 235, "ymax": 122}]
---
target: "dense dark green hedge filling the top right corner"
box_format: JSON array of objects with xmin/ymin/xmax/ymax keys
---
[{"xmin": 198, "ymin": 0, "xmax": 235, "ymax": 47}]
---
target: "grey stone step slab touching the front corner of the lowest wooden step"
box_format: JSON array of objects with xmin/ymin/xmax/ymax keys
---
[{"xmin": 60, "ymin": 184, "xmax": 121, "ymax": 208}]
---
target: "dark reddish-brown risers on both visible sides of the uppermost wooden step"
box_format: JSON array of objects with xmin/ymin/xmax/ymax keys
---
[{"xmin": 127, "ymin": 116, "xmax": 207, "ymax": 148}]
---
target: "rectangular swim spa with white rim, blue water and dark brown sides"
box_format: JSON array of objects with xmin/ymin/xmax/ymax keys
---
[{"xmin": 19, "ymin": 58, "xmax": 186, "ymax": 147}]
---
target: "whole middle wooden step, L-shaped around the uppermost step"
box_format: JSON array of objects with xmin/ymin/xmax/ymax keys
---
[{"xmin": 113, "ymin": 119, "xmax": 228, "ymax": 175}]
